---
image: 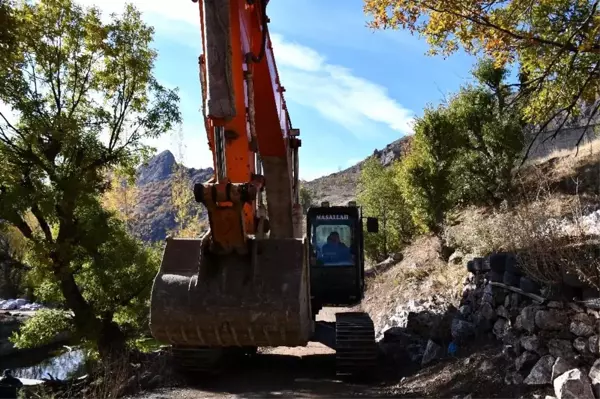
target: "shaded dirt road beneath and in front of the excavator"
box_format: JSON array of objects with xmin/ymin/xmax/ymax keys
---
[{"xmin": 135, "ymin": 309, "xmax": 552, "ymax": 399}]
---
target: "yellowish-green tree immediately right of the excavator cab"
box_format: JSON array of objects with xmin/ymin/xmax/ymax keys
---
[{"xmin": 357, "ymin": 157, "xmax": 414, "ymax": 260}]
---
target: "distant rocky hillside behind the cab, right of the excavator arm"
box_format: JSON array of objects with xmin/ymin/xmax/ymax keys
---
[{"xmin": 303, "ymin": 136, "xmax": 412, "ymax": 205}]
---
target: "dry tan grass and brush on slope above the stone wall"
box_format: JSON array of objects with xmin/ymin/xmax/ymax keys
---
[{"xmin": 446, "ymin": 170, "xmax": 600, "ymax": 288}]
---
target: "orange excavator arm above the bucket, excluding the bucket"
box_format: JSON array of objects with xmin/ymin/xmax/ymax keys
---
[{"xmin": 194, "ymin": 0, "xmax": 302, "ymax": 254}]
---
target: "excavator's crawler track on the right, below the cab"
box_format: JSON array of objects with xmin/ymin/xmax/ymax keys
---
[{"xmin": 335, "ymin": 312, "xmax": 377, "ymax": 377}]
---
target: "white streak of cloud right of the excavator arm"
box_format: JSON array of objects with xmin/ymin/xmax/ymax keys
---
[{"xmin": 271, "ymin": 34, "xmax": 413, "ymax": 137}]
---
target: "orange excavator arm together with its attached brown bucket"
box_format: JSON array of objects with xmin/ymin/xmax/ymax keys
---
[{"xmin": 150, "ymin": 0, "xmax": 314, "ymax": 364}]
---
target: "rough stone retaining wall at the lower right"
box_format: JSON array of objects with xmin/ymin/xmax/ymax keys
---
[{"xmin": 462, "ymin": 258, "xmax": 600, "ymax": 399}]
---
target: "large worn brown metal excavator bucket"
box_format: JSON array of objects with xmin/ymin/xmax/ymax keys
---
[{"xmin": 150, "ymin": 236, "xmax": 312, "ymax": 347}]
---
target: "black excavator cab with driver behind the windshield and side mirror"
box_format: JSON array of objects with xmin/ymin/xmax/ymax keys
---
[{"xmin": 306, "ymin": 205, "xmax": 378, "ymax": 314}]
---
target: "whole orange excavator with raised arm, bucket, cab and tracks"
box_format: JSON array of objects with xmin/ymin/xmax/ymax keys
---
[{"xmin": 150, "ymin": 0, "xmax": 378, "ymax": 375}]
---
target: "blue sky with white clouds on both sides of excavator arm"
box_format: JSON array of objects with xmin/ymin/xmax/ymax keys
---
[{"xmin": 82, "ymin": 0, "xmax": 474, "ymax": 180}]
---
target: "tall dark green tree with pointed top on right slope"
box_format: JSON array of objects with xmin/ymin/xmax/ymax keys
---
[{"xmin": 447, "ymin": 59, "xmax": 524, "ymax": 205}]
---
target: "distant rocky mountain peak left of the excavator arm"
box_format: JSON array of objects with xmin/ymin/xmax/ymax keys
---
[{"xmin": 134, "ymin": 151, "xmax": 213, "ymax": 241}]
